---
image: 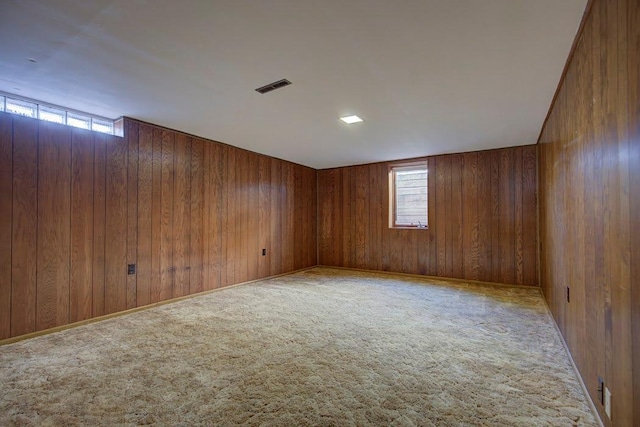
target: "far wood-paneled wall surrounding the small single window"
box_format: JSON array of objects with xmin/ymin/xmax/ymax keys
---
[{"xmin": 318, "ymin": 145, "xmax": 538, "ymax": 285}]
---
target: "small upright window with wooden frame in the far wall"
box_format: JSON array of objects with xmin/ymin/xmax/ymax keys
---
[{"xmin": 389, "ymin": 162, "xmax": 428, "ymax": 228}]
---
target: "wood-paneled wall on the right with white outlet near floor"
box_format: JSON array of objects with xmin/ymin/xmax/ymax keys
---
[{"xmin": 540, "ymin": 0, "xmax": 640, "ymax": 426}]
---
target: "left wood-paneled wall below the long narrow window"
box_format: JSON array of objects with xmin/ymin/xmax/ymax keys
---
[{"xmin": 0, "ymin": 113, "xmax": 317, "ymax": 339}]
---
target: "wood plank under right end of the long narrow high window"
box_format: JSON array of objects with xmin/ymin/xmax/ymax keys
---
[{"xmin": 104, "ymin": 135, "xmax": 128, "ymax": 314}]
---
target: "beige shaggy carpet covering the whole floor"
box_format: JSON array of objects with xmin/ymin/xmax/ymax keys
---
[{"xmin": 0, "ymin": 268, "xmax": 595, "ymax": 426}]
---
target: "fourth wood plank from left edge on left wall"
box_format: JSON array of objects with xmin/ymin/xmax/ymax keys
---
[{"xmin": 69, "ymin": 129, "xmax": 95, "ymax": 322}]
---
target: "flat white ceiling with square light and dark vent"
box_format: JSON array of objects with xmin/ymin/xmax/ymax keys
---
[{"xmin": 0, "ymin": 0, "xmax": 587, "ymax": 168}]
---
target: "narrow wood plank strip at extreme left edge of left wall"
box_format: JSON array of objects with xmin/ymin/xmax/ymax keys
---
[{"xmin": 0, "ymin": 113, "xmax": 13, "ymax": 340}]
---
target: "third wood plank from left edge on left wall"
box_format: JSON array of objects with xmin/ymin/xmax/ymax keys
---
[{"xmin": 36, "ymin": 122, "xmax": 71, "ymax": 330}]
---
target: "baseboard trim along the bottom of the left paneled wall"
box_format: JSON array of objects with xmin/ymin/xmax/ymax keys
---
[{"xmin": 0, "ymin": 265, "xmax": 317, "ymax": 347}]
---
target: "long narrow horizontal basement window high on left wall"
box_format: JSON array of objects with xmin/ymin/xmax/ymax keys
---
[{"xmin": 0, "ymin": 94, "xmax": 115, "ymax": 135}]
